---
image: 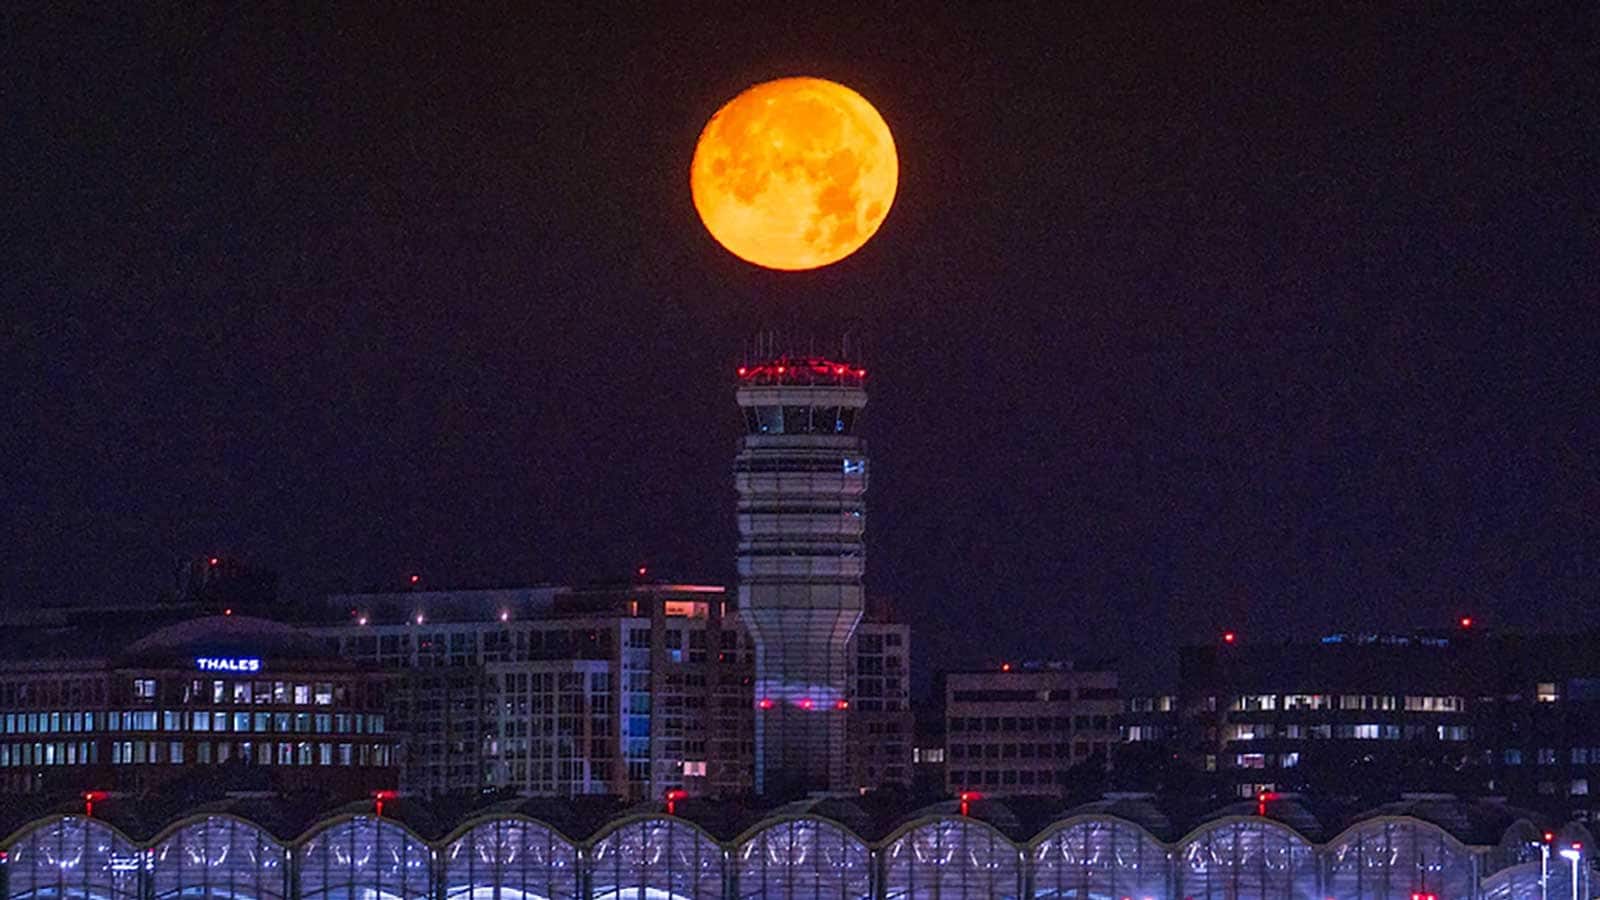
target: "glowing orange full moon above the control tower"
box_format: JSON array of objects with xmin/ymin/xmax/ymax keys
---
[{"xmin": 690, "ymin": 78, "xmax": 899, "ymax": 271}]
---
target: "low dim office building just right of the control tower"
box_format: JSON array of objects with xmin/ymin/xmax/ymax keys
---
[{"xmin": 944, "ymin": 661, "xmax": 1122, "ymax": 796}]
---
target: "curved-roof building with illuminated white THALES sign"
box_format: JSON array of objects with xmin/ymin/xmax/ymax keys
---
[{"xmin": 0, "ymin": 617, "xmax": 398, "ymax": 794}]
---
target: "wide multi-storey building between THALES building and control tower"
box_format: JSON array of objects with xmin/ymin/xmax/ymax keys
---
[{"xmin": 317, "ymin": 583, "xmax": 754, "ymax": 801}]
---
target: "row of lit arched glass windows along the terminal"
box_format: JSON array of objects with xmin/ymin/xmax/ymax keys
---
[{"xmin": 0, "ymin": 815, "xmax": 1548, "ymax": 900}]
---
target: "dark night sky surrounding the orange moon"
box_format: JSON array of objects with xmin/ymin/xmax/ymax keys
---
[{"xmin": 0, "ymin": 3, "xmax": 1600, "ymax": 685}]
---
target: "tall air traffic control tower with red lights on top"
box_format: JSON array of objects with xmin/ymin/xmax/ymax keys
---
[{"xmin": 734, "ymin": 356, "xmax": 867, "ymax": 794}]
